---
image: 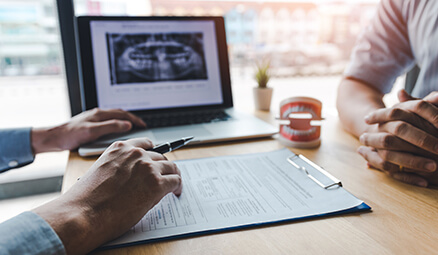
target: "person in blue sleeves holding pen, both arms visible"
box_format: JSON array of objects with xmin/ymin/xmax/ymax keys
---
[{"xmin": 0, "ymin": 109, "xmax": 182, "ymax": 254}]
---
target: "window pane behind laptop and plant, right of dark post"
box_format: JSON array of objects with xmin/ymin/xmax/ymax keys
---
[{"xmin": 71, "ymin": 0, "xmax": 378, "ymax": 77}]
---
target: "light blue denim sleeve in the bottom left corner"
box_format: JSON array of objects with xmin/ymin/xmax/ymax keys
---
[{"xmin": 0, "ymin": 212, "xmax": 66, "ymax": 254}]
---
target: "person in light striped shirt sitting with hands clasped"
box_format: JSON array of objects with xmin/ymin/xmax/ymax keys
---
[{"xmin": 337, "ymin": 0, "xmax": 438, "ymax": 187}]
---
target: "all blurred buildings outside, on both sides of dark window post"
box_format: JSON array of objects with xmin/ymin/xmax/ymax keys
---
[{"xmin": 0, "ymin": 0, "xmax": 377, "ymax": 76}]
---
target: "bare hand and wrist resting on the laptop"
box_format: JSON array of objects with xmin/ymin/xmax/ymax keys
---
[{"xmin": 32, "ymin": 108, "xmax": 146, "ymax": 154}]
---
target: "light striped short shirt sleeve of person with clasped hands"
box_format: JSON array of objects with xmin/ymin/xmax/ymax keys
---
[{"xmin": 344, "ymin": 0, "xmax": 415, "ymax": 93}]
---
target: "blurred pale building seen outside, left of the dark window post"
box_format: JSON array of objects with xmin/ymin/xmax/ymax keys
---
[{"xmin": 0, "ymin": 0, "xmax": 60, "ymax": 76}]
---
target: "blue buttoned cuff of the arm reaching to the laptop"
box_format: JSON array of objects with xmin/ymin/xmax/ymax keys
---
[{"xmin": 0, "ymin": 128, "xmax": 34, "ymax": 173}]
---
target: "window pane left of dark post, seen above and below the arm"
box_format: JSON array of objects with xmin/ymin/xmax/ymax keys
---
[{"xmin": 0, "ymin": 0, "xmax": 70, "ymax": 186}]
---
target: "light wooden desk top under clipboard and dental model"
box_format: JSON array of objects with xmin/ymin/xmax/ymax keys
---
[{"xmin": 63, "ymin": 109, "xmax": 438, "ymax": 254}]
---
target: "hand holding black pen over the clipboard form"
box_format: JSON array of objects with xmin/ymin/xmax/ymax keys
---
[{"xmin": 34, "ymin": 139, "xmax": 182, "ymax": 254}]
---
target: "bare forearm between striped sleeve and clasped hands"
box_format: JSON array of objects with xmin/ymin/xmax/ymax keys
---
[{"xmin": 336, "ymin": 78, "xmax": 385, "ymax": 137}]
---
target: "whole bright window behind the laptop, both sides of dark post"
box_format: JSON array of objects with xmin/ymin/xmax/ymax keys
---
[{"xmin": 0, "ymin": 0, "xmax": 378, "ymax": 193}]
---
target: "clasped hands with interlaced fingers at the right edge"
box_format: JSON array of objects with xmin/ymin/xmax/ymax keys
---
[{"xmin": 358, "ymin": 91, "xmax": 438, "ymax": 186}]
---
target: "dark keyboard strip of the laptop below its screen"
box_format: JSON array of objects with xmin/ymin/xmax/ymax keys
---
[{"xmin": 141, "ymin": 110, "xmax": 231, "ymax": 128}]
